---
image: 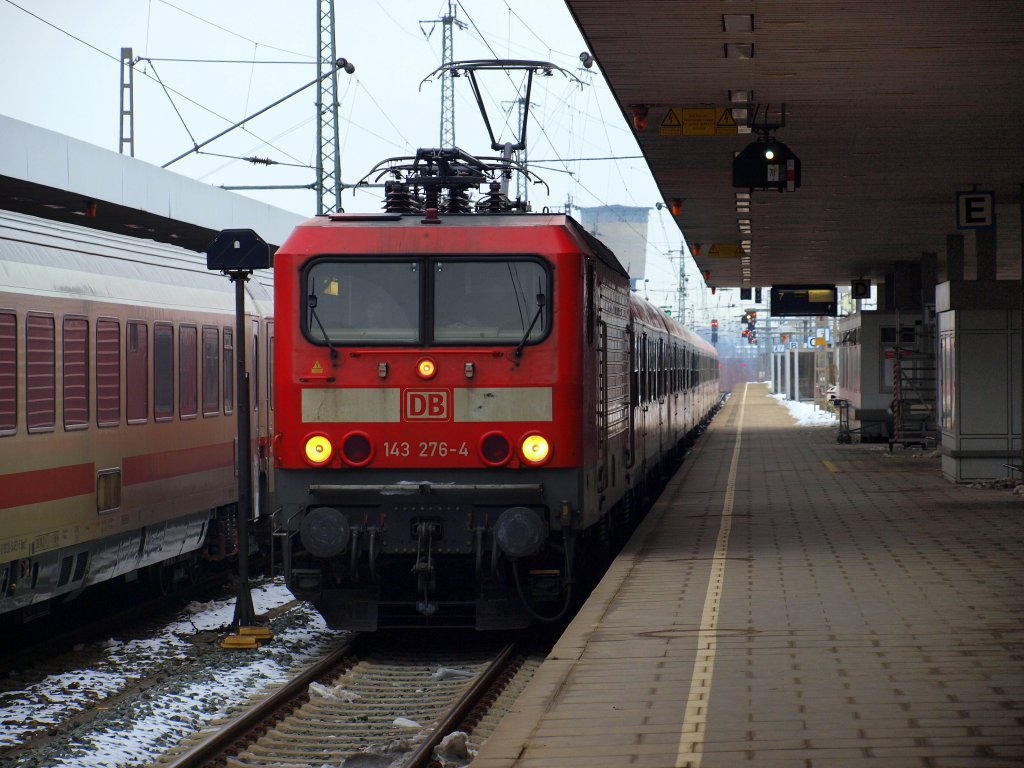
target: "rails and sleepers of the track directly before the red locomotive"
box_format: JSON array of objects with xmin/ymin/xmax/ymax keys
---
[{"xmin": 161, "ymin": 639, "xmax": 542, "ymax": 768}]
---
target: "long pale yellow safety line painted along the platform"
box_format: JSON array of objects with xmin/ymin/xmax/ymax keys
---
[{"xmin": 676, "ymin": 384, "xmax": 746, "ymax": 768}]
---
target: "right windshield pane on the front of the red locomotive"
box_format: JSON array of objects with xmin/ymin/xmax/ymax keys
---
[{"xmin": 432, "ymin": 259, "xmax": 548, "ymax": 344}]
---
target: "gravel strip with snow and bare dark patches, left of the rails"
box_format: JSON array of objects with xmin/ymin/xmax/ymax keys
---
[{"xmin": 0, "ymin": 585, "xmax": 342, "ymax": 768}]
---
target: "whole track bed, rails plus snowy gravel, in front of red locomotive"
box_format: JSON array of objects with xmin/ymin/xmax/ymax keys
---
[{"xmin": 0, "ymin": 585, "xmax": 551, "ymax": 768}]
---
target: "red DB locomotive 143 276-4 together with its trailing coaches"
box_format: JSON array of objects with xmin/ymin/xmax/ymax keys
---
[{"xmin": 272, "ymin": 150, "xmax": 720, "ymax": 630}]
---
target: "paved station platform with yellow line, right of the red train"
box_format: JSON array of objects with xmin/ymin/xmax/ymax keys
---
[{"xmin": 472, "ymin": 384, "xmax": 1024, "ymax": 768}]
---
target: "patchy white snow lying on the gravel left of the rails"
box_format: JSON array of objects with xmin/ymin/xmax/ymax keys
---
[{"xmin": 0, "ymin": 579, "xmax": 338, "ymax": 768}]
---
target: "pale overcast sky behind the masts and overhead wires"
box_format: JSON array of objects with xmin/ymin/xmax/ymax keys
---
[{"xmin": 0, "ymin": 0, "xmax": 737, "ymax": 319}]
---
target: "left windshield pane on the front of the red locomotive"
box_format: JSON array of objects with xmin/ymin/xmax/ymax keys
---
[{"xmin": 302, "ymin": 260, "xmax": 422, "ymax": 345}]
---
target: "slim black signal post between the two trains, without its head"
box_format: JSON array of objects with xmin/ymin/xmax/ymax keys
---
[{"xmin": 228, "ymin": 269, "xmax": 256, "ymax": 627}]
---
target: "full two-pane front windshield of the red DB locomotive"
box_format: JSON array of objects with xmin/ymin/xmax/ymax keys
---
[{"xmin": 305, "ymin": 258, "xmax": 551, "ymax": 345}]
